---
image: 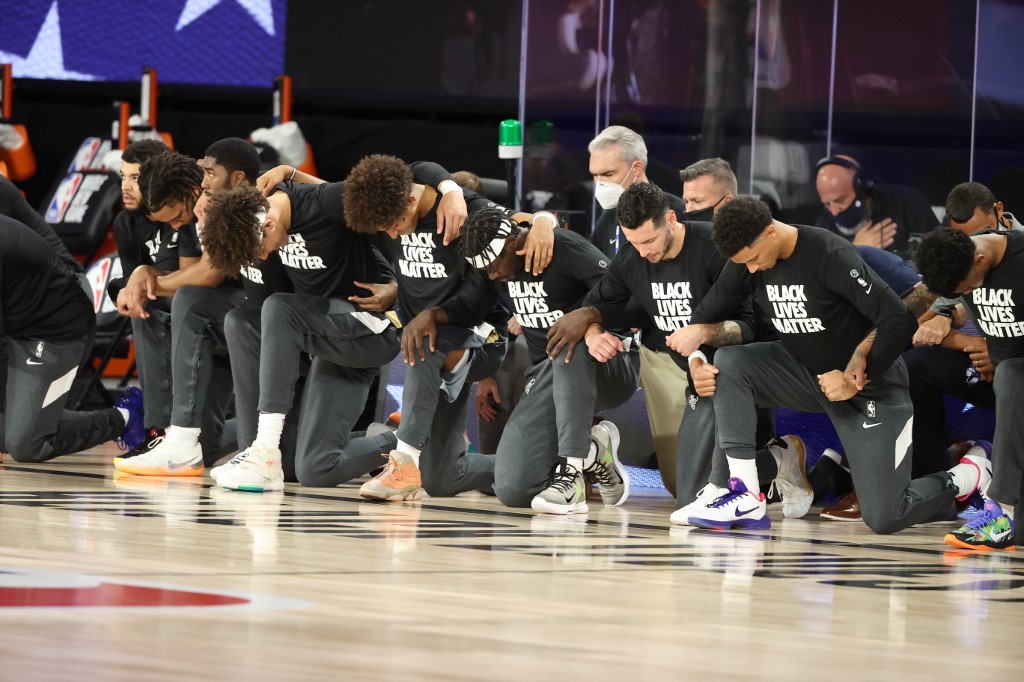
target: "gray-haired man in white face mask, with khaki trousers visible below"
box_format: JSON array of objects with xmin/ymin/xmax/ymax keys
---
[{"xmin": 587, "ymin": 126, "xmax": 686, "ymax": 495}]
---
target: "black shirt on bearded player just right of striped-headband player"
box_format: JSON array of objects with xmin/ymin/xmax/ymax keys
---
[{"xmin": 584, "ymin": 222, "xmax": 755, "ymax": 370}]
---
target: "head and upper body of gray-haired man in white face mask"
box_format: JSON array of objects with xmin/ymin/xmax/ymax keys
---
[{"xmin": 587, "ymin": 126, "xmax": 686, "ymax": 258}]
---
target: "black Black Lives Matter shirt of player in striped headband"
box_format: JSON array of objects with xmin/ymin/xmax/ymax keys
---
[{"xmin": 441, "ymin": 229, "xmax": 608, "ymax": 364}]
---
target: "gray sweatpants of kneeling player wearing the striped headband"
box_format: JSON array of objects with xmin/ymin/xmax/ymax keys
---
[{"xmin": 495, "ymin": 345, "xmax": 640, "ymax": 507}]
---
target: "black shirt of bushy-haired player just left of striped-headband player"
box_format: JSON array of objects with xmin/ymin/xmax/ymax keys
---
[{"xmin": 385, "ymin": 189, "xmax": 507, "ymax": 323}]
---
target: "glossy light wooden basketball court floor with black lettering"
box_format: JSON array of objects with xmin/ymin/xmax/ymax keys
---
[{"xmin": 0, "ymin": 447, "xmax": 1024, "ymax": 681}]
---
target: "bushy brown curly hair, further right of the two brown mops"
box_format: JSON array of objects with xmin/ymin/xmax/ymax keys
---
[{"xmin": 342, "ymin": 154, "xmax": 413, "ymax": 235}]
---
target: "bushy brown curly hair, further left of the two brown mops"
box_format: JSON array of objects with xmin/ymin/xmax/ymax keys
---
[{"xmin": 203, "ymin": 185, "xmax": 270, "ymax": 276}]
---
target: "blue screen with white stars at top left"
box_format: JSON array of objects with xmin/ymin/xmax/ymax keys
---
[{"xmin": 0, "ymin": 0, "xmax": 287, "ymax": 87}]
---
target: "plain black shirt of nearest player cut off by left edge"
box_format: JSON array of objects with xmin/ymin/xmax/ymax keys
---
[{"xmin": 0, "ymin": 215, "xmax": 95, "ymax": 342}]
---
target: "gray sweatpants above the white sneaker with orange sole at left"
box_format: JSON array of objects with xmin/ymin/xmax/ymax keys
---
[{"xmin": 170, "ymin": 287, "xmax": 246, "ymax": 458}]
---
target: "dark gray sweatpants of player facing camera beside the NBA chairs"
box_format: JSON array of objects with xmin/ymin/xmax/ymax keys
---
[{"xmin": 131, "ymin": 306, "xmax": 173, "ymax": 429}]
